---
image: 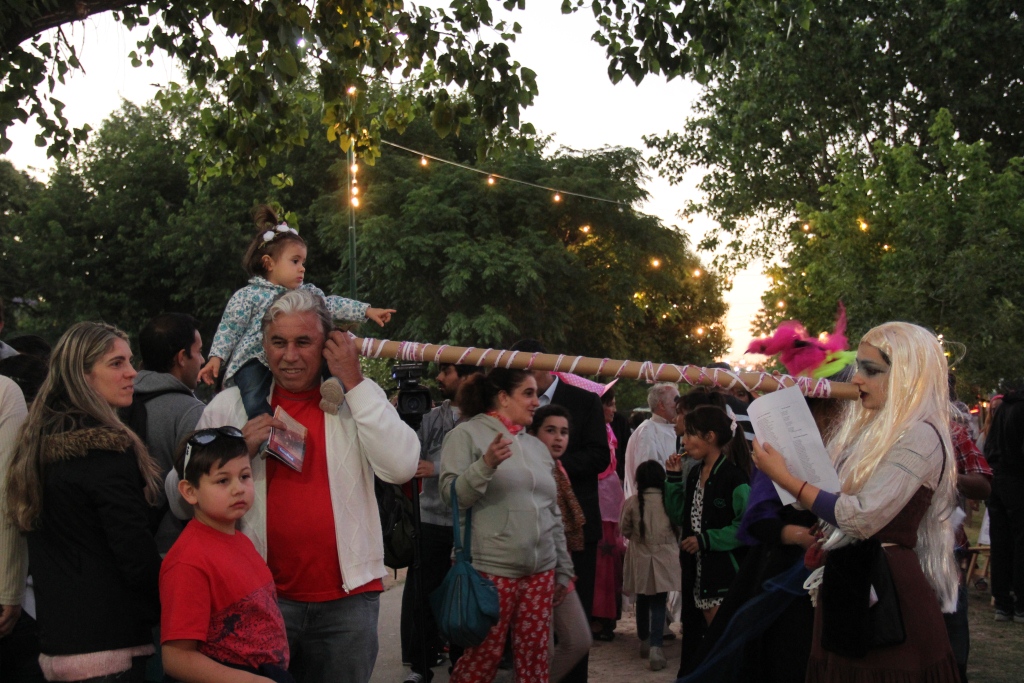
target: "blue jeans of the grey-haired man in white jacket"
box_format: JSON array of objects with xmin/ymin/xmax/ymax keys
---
[{"xmin": 278, "ymin": 592, "xmax": 380, "ymax": 683}]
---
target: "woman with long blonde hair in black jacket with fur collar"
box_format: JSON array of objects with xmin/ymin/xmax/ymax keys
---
[{"xmin": 3, "ymin": 323, "xmax": 160, "ymax": 682}]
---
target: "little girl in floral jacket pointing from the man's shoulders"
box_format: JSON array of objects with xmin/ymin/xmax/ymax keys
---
[{"xmin": 199, "ymin": 205, "xmax": 394, "ymax": 419}]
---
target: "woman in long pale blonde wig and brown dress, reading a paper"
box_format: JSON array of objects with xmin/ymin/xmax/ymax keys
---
[{"xmin": 755, "ymin": 323, "xmax": 958, "ymax": 683}]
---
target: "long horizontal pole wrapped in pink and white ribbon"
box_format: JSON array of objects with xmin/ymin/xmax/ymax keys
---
[{"xmin": 355, "ymin": 337, "xmax": 860, "ymax": 400}]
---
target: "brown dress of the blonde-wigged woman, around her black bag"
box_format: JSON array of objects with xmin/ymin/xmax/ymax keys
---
[{"xmin": 807, "ymin": 486, "xmax": 959, "ymax": 683}]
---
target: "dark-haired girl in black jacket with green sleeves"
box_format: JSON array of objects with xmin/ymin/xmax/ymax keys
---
[{"xmin": 665, "ymin": 405, "xmax": 751, "ymax": 624}]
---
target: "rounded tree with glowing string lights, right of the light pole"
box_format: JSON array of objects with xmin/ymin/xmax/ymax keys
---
[{"xmin": 329, "ymin": 116, "xmax": 727, "ymax": 361}]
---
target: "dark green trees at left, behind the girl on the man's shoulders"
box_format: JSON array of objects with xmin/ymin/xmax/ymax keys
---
[{"xmin": 0, "ymin": 95, "xmax": 337, "ymax": 340}]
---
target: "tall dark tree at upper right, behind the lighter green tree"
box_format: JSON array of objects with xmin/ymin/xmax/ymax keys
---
[{"xmin": 646, "ymin": 0, "xmax": 1024, "ymax": 266}]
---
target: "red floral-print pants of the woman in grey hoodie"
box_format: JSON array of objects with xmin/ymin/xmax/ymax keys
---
[{"xmin": 451, "ymin": 569, "xmax": 555, "ymax": 683}]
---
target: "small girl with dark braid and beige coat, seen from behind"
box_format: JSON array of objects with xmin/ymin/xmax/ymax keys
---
[{"xmin": 618, "ymin": 460, "xmax": 681, "ymax": 671}]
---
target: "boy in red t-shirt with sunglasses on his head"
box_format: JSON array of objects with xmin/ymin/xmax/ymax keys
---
[{"xmin": 160, "ymin": 427, "xmax": 294, "ymax": 683}]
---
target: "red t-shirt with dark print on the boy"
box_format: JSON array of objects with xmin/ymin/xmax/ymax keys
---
[{"xmin": 160, "ymin": 519, "xmax": 289, "ymax": 669}]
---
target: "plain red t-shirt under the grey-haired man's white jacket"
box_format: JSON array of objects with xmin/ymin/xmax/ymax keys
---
[{"xmin": 266, "ymin": 387, "xmax": 384, "ymax": 602}]
